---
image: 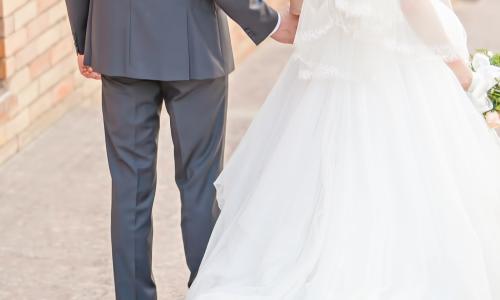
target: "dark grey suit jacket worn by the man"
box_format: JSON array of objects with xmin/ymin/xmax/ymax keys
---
[{"xmin": 66, "ymin": 0, "xmax": 278, "ymax": 81}]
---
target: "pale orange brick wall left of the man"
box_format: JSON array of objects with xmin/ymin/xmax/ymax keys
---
[{"xmin": 0, "ymin": 0, "xmax": 101, "ymax": 162}]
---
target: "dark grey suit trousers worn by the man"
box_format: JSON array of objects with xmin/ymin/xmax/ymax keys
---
[{"xmin": 102, "ymin": 76, "xmax": 227, "ymax": 300}]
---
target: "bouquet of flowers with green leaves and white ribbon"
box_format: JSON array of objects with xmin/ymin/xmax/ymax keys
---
[{"xmin": 469, "ymin": 49, "xmax": 500, "ymax": 128}]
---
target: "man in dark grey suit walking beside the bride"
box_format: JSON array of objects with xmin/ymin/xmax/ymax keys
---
[{"xmin": 66, "ymin": 0, "xmax": 297, "ymax": 300}]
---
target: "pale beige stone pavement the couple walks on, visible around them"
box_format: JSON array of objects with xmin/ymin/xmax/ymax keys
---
[{"xmin": 0, "ymin": 0, "xmax": 500, "ymax": 300}]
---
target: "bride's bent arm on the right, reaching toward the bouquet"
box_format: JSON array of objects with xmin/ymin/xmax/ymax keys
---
[{"xmin": 400, "ymin": 0, "xmax": 473, "ymax": 90}]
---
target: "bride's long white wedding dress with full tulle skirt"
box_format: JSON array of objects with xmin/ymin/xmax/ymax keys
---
[{"xmin": 187, "ymin": 0, "xmax": 500, "ymax": 300}]
